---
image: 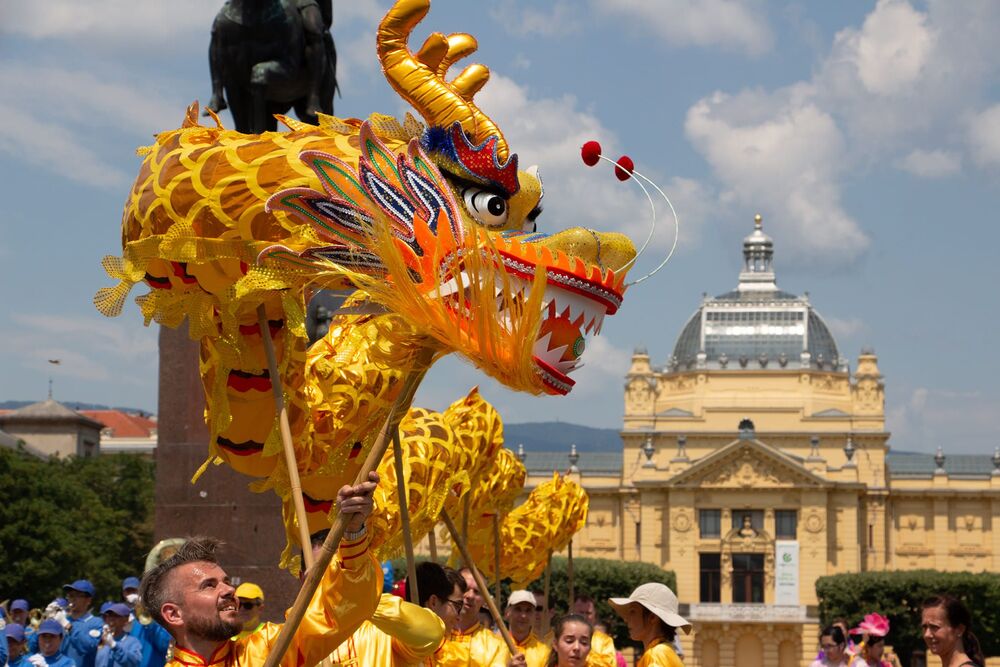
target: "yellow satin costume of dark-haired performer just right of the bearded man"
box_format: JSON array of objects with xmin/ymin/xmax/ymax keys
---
[{"xmin": 329, "ymin": 593, "xmax": 444, "ymax": 667}]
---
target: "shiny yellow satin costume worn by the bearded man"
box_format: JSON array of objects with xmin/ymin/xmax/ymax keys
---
[{"xmin": 166, "ymin": 534, "xmax": 382, "ymax": 667}]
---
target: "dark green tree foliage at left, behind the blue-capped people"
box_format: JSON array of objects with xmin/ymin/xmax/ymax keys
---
[{"xmin": 0, "ymin": 449, "xmax": 153, "ymax": 607}]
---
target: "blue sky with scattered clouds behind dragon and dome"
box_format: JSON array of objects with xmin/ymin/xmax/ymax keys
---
[{"xmin": 0, "ymin": 0, "xmax": 1000, "ymax": 453}]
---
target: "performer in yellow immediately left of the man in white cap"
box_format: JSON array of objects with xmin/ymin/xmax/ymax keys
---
[{"xmin": 436, "ymin": 569, "xmax": 527, "ymax": 667}]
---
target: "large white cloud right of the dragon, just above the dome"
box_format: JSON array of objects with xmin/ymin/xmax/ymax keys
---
[{"xmin": 685, "ymin": 89, "xmax": 869, "ymax": 264}]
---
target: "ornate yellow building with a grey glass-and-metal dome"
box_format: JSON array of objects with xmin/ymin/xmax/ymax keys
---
[{"xmin": 526, "ymin": 216, "xmax": 1000, "ymax": 667}]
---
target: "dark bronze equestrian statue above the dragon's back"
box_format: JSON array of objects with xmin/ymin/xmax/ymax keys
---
[{"xmin": 206, "ymin": 0, "xmax": 337, "ymax": 134}]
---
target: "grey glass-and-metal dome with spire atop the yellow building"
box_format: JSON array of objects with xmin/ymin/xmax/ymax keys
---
[{"xmin": 667, "ymin": 215, "xmax": 847, "ymax": 372}]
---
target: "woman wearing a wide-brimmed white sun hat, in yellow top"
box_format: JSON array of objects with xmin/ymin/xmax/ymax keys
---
[{"xmin": 608, "ymin": 583, "xmax": 691, "ymax": 667}]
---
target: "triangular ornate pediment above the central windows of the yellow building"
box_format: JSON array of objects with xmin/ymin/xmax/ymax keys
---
[{"xmin": 669, "ymin": 440, "xmax": 829, "ymax": 489}]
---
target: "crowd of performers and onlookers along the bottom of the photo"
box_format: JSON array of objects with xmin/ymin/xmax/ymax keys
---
[{"xmin": 0, "ymin": 473, "xmax": 985, "ymax": 667}]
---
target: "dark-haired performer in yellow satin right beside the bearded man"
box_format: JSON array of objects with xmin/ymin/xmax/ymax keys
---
[{"xmin": 329, "ymin": 561, "xmax": 464, "ymax": 667}]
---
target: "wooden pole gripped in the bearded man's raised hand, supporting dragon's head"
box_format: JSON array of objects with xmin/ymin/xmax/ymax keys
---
[{"xmin": 263, "ymin": 365, "xmax": 427, "ymax": 667}]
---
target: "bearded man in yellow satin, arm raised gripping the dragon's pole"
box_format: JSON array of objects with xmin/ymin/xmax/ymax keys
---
[{"xmin": 139, "ymin": 472, "xmax": 382, "ymax": 667}]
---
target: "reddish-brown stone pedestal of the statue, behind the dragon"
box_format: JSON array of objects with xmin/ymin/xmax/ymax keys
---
[{"xmin": 154, "ymin": 325, "xmax": 299, "ymax": 621}]
